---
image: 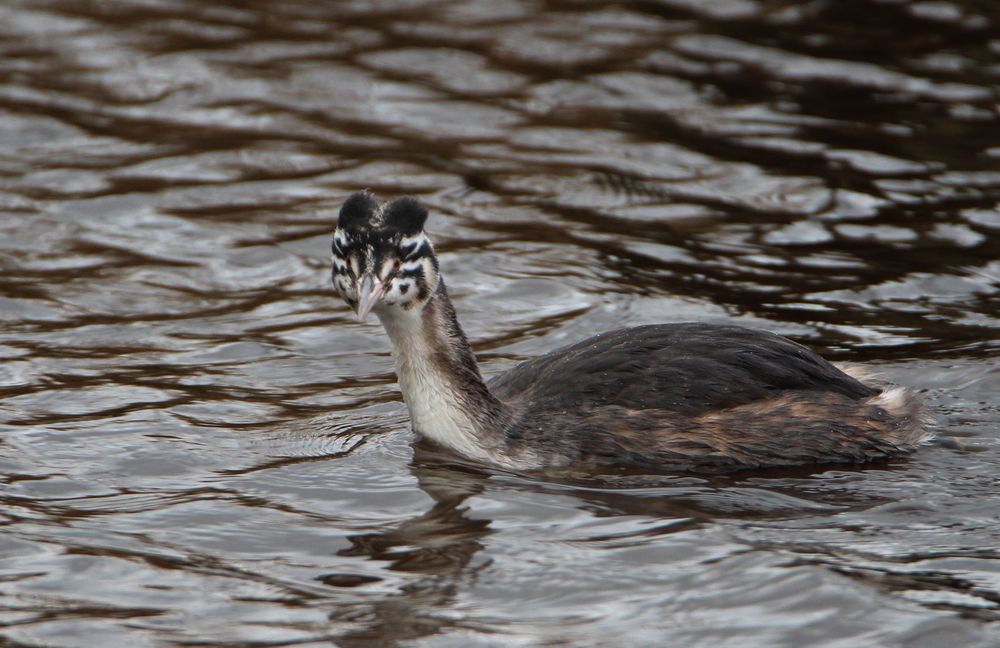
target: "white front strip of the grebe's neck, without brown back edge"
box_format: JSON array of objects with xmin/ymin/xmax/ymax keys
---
[{"xmin": 376, "ymin": 304, "xmax": 491, "ymax": 459}]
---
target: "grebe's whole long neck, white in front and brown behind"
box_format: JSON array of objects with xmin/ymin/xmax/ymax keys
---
[{"xmin": 376, "ymin": 280, "xmax": 507, "ymax": 459}]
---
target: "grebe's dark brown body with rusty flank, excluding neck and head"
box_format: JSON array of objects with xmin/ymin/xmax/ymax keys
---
[{"xmin": 489, "ymin": 323, "xmax": 923, "ymax": 470}]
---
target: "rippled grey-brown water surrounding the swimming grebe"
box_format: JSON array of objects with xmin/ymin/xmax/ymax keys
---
[{"xmin": 0, "ymin": 0, "xmax": 1000, "ymax": 648}]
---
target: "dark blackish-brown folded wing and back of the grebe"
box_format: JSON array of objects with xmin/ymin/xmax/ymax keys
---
[{"xmin": 490, "ymin": 324, "xmax": 877, "ymax": 417}]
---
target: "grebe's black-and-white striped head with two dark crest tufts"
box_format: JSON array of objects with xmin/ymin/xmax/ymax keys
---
[{"xmin": 333, "ymin": 192, "xmax": 439, "ymax": 320}]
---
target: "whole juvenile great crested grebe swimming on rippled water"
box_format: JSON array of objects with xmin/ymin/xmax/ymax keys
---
[{"xmin": 333, "ymin": 193, "xmax": 929, "ymax": 470}]
